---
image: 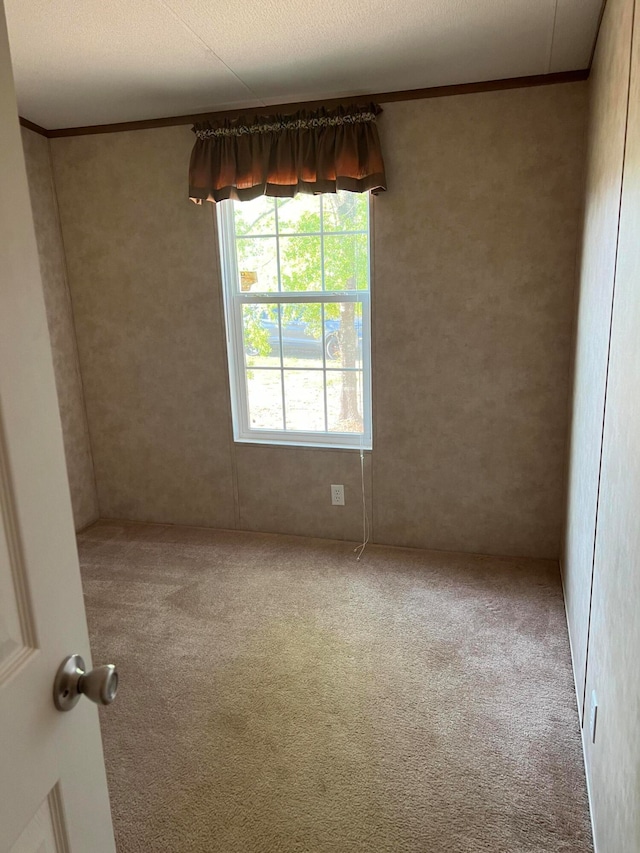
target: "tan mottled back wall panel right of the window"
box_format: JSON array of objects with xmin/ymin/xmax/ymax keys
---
[{"xmin": 373, "ymin": 84, "xmax": 586, "ymax": 557}]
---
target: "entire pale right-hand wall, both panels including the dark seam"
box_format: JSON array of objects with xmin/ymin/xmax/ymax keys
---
[{"xmin": 563, "ymin": 0, "xmax": 640, "ymax": 853}]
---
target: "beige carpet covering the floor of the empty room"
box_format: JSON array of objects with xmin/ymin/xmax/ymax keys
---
[{"xmin": 79, "ymin": 522, "xmax": 592, "ymax": 853}]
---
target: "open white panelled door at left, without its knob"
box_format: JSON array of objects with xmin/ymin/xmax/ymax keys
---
[{"xmin": 0, "ymin": 0, "xmax": 115, "ymax": 853}]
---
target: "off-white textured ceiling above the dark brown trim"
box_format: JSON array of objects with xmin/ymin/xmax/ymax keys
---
[{"xmin": 5, "ymin": 0, "xmax": 602, "ymax": 129}]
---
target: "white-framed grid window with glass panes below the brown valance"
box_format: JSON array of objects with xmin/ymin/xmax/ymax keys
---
[{"xmin": 218, "ymin": 192, "xmax": 371, "ymax": 449}]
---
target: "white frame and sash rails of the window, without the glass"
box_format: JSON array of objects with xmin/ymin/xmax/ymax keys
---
[{"xmin": 216, "ymin": 191, "xmax": 373, "ymax": 450}]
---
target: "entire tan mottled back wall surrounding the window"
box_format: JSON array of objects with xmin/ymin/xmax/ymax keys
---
[{"xmin": 52, "ymin": 83, "xmax": 586, "ymax": 557}]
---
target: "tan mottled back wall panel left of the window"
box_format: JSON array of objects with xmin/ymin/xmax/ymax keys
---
[{"xmin": 52, "ymin": 127, "xmax": 235, "ymax": 527}]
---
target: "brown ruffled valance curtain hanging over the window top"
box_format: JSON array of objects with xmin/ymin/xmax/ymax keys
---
[{"xmin": 189, "ymin": 104, "xmax": 387, "ymax": 204}]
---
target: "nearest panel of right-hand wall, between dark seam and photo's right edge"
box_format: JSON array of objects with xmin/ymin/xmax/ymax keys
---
[{"xmin": 587, "ymin": 8, "xmax": 640, "ymax": 853}]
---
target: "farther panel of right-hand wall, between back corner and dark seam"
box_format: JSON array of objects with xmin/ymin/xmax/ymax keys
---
[{"xmin": 563, "ymin": 0, "xmax": 633, "ymax": 724}]
